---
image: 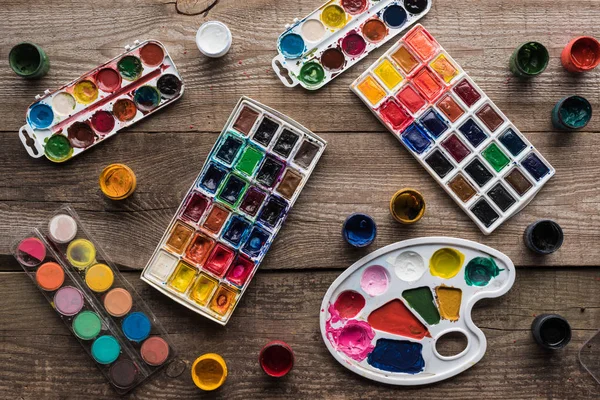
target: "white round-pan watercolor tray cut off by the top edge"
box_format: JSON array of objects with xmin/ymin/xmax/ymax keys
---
[{"xmin": 271, "ymin": 0, "xmax": 432, "ymax": 90}]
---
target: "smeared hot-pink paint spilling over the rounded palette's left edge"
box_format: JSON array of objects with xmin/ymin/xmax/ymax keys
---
[{"xmin": 326, "ymin": 320, "xmax": 375, "ymax": 361}]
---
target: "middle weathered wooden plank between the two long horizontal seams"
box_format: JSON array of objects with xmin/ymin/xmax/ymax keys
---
[{"xmin": 0, "ymin": 128, "xmax": 600, "ymax": 269}]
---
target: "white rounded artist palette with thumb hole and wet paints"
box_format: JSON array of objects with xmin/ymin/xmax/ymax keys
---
[{"xmin": 320, "ymin": 237, "xmax": 515, "ymax": 385}]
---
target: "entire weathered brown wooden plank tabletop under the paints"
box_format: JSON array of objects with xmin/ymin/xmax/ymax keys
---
[{"xmin": 0, "ymin": 0, "xmax": 600, "ymax": 399}]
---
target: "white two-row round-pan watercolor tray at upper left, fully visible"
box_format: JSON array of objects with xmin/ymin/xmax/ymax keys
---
[{"xmin": 19, "ymin": 40, "xmax": 184, "ymax": 162}]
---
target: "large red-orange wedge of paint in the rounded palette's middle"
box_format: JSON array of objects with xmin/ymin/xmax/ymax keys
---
[{"xmin": 368, "ymin": 299, "xmax": 430, "ymax": 339}]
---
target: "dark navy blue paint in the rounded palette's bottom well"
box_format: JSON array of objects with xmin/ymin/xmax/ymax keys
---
[{"xmin": 367, "ymin": 339, "xmax": 425, "ymax": 375}]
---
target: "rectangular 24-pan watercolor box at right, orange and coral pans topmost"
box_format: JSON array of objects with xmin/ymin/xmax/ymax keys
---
[{"xmin": 351, "ymin": 24, "xmax": 555, "ymax": 235}]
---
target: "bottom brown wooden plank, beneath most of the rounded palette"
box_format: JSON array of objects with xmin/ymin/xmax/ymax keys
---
[{"xmin": 0, "ymin": 269, "xmax": 600, "ymax": 399}]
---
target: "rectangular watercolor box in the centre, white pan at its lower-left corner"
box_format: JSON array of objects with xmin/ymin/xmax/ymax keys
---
[{"xmin": 141, "ymin": 97, "xmax": 326, "ymax": 325}]
